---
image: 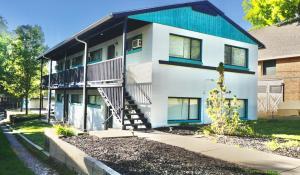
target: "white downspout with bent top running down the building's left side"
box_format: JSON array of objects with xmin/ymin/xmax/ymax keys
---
[{"xmin": 75, "ymin": 36, "xmax": 88, "ymax": 132}]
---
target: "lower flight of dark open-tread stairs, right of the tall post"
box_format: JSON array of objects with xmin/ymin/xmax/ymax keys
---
[{"xmin": 123, "ymin": 92, "xmax": 151, "ymax": 130}]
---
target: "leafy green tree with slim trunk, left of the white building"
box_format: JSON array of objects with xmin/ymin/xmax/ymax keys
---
[{"xmin": 2, "ymin": 25, "xmax": 45, "ymax": 114}]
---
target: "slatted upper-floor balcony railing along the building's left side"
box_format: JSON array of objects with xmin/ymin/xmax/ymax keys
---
[{"xmin": 42, "ymin": 57, "xmax": 123, "ymax": 89}]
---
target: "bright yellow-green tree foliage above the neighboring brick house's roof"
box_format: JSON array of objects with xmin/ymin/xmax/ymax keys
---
[{"xmin": 242, "ymin": 0, "xmax": 300, "ymax": 29}]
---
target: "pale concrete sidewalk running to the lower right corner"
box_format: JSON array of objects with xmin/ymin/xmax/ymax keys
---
[{"xmin": 135, "ymin": 131, "xmax": 300, "ymax": 175}]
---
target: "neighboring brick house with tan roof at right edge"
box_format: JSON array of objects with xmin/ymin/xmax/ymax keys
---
[{"xmin": 250, "ymin": 20, "xmax": 300, "ymax": 115}]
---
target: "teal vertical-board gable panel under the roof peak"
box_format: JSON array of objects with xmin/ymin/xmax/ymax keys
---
[{"xmin": 129, "ymin": 7, "xmax": 257, "ymax": 45}]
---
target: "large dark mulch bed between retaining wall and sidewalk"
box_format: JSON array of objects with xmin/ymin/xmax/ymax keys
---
[{"xmin": 63, "ymin": 135, "xmax": 262, "ymax": 175}]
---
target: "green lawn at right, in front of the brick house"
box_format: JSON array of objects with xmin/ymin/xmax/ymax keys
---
[{"xmin": 247, "ymin": 118, "xmax": 300, "ymax": 141}]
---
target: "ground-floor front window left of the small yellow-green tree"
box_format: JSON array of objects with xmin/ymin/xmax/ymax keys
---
[{"xmin": 168, "ymin": 97, "xmax": 200, "ymax": 121}]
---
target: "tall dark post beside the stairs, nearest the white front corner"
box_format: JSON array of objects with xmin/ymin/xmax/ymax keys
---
[{"xmin": 121, "ymin": 17, "xmax": 128, "ymax": 129}]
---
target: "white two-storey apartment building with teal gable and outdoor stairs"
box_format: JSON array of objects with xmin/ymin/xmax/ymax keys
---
[{"xmin": 39, "ymin": 1, "xmax": 263, "ymax": 130}]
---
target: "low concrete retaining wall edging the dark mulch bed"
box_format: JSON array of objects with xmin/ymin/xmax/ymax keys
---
[{"xmin": 45, "ymin": 129, "xmax": 119, "ymax": 175}]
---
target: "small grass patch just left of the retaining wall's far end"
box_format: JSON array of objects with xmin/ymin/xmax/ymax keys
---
[{"xmin": 13, "ymin": 119, "xmax": 52, "ymax": 148}]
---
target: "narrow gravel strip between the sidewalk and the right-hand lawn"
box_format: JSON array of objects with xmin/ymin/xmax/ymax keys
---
[{"xmin": 214, "ymin": 136, "xmax": 300, "ymax": 159}]
